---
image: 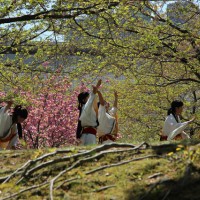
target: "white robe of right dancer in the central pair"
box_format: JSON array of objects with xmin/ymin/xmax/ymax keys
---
[{"xmin": 97, "ymin": 105, "xmax": 117, "ymax": 144}]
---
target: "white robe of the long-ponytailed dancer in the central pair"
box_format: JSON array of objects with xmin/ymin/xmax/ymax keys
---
[{"xmin": 79, "ymin": 92, "xmax": 97, "ymax": 145}]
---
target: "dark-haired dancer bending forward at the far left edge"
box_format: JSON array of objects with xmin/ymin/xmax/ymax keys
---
[{"xmin": 0, "ymin": 101, "xmax": 28, "ymax": 149}]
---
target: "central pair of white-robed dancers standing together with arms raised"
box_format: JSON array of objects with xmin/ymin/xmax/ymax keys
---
[{"xmin": 76, "ymin": 80, "xmax": 118, "ymax": 145}]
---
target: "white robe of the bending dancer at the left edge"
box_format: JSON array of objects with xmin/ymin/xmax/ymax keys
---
[{"xmin": 0, "ymin": 107, "xmax": 18, "ymax": 150}]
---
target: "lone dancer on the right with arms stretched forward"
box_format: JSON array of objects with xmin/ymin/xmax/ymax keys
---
[{"xmin": 160, "ymin": 100, "xmax": 195, "ymax": 141}]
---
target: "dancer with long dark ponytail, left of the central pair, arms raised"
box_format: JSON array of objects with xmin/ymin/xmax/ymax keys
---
[{"xmin": 76, "ymin": 80, "xmax": 101, "ymax": 145}]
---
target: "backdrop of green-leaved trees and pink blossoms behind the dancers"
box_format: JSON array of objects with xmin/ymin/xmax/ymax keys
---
[{"xmin": 0, "ymin": 0, "xmax": 200, "ymax": 148}]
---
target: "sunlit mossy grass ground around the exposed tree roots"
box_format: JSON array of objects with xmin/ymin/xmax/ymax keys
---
[{"xmin": 0, "ymin": 141, "xmax": 200, "ymax": 200}]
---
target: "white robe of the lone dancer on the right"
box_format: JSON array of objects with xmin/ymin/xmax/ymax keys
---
[{"xmin": 163, "ymin": 114, "xmax": 190, "ymax": 140}]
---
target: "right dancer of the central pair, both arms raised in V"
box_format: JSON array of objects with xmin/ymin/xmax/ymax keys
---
[{"xmin": 97, "ymin": 91, "xmax": 118, "ymax": 144}]
